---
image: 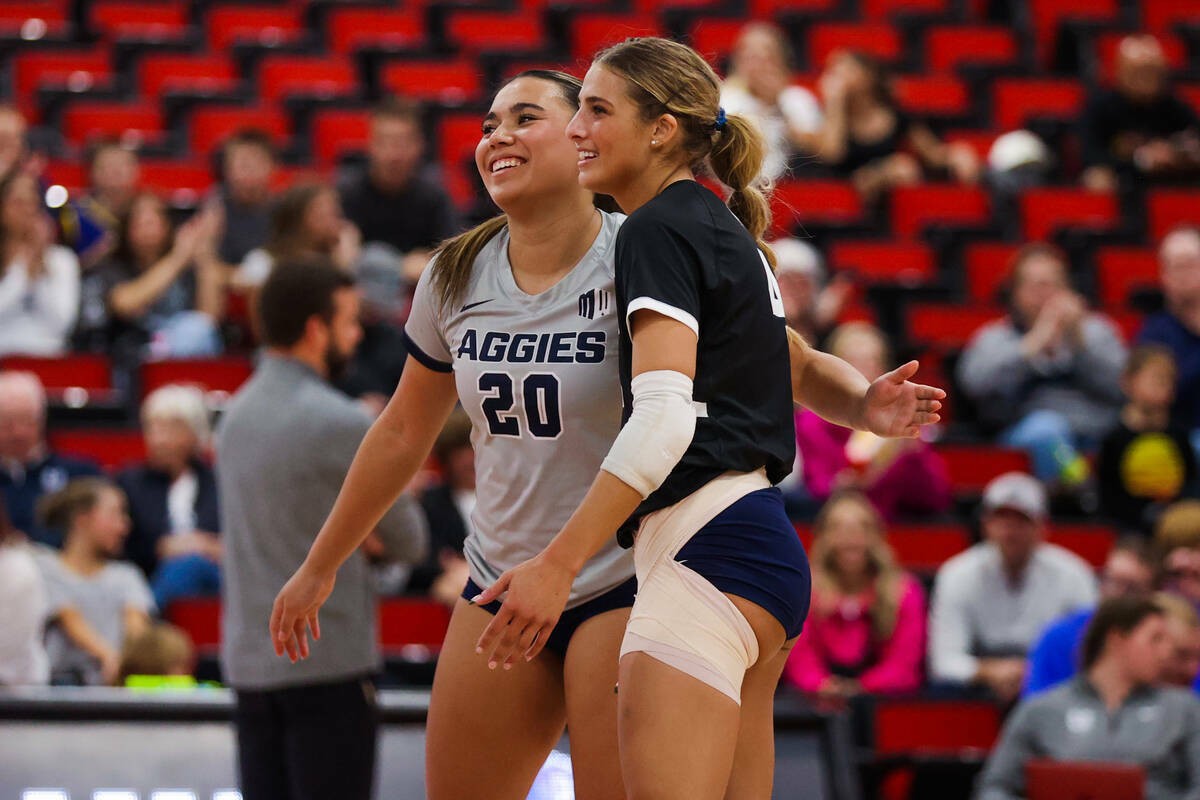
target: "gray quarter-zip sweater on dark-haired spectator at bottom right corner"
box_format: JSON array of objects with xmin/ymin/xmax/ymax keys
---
[{"xmin": 976, "ymin": 676, "xmax": 1200, "ymax": 800}]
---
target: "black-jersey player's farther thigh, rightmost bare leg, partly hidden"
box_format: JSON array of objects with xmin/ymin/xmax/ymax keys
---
[{"xmin": 725, "ymin": 638, "xmax": 796, "ymax": 800}]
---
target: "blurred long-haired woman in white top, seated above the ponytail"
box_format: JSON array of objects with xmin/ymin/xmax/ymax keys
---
[{"xmin": 721, "ymin": 22, "xmax": 822, "ymax": 180}]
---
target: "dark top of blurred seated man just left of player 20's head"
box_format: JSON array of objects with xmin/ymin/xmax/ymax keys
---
[{"xmin": 340, "ymin": 170, "xmax": 458, "ymax": 253}]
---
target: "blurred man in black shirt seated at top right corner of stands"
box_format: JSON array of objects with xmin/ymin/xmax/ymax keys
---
[{"xmin": 1080, "ymin": 34, "xmax": 1200, "ymax": 192}]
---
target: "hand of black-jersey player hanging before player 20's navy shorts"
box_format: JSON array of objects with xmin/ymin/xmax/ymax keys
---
[{"xmin": 472, "ymin": 553, "xmax": 575, "ymax": 669}]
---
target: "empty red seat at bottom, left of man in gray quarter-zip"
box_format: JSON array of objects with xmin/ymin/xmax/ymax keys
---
[{"xmin": 874, "ymin": 699, "xmax": 1001, "ymax": 754}]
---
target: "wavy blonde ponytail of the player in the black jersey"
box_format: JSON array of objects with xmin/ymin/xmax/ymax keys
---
[{"xmin": 708, "ymin": 114, "xmax": 775, "ymax": 270}]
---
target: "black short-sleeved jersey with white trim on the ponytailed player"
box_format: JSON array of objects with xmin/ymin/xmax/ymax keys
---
[{"xmin": 616, "ymin": 180, "xmax": 796, "ymax": 534}]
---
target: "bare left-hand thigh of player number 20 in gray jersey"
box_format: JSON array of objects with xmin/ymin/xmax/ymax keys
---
[{"xmin": 425, "ymin": 599, "xmax": 566, "ymax": 800}]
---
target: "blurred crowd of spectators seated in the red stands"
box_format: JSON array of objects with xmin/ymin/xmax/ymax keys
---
[{"xmin": 0, "ymin": 6, "xmax": 1200, "ymax": 799}]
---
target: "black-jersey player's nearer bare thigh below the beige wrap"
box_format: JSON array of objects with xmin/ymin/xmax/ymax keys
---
[{"xmin": 618, "ymin": 651, "xmax": 739, "ymax": 800}]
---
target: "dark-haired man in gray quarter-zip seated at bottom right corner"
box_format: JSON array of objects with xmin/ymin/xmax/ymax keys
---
[{"xmin": 978, "ymin": 597, "xmax": 1200, "ymax": 800}]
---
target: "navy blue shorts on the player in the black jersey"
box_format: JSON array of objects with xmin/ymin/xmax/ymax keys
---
[{"xmin": 676, "ymin": 487, "xmax": 812, "ymax": 639}]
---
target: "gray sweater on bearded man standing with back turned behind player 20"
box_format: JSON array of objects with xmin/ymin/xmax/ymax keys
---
[{"xmin": 217, "ymin": 355, "xmax": 428, "ymax": 690}]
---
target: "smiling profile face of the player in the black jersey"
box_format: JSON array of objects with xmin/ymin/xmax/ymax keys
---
[{"xmin": 566, "ymin": 64, "xmax": 665, "ymax": 203}]
